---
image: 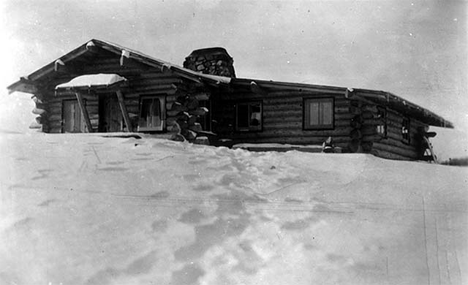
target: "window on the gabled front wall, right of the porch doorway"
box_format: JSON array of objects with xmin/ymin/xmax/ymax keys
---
[{"xmin": 138, "ymin": 96, "xmax": 165, "ymax": 131}]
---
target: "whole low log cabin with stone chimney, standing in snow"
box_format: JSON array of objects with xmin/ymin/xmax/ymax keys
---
[{"xmin": 8, "ymin": 39, "xmax": 453, "ymax": 161}]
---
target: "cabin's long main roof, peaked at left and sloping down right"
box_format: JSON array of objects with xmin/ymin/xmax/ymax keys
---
[{"xmin": 7, "ymin": 39, "xmax": 453, "ymax": 128}]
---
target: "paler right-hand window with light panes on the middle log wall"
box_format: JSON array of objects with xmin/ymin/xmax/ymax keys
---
[{"xmin": 304, "ymin": 98, "xmax": 334, "ymax": 130}]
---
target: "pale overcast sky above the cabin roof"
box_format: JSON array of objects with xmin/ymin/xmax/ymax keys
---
[{"xmin": 0, "ymin": 0, "xmax": 468, "ymax": 134}]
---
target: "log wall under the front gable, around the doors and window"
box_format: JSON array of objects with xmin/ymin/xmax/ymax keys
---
[{"xmin": 36, "ymin": 72, "xmax": 209, "ymax": 140}]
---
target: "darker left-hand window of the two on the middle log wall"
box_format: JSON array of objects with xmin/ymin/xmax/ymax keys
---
[{"xmin": 236, "ymin": 102, "xmax": 262, "ymax": 132}]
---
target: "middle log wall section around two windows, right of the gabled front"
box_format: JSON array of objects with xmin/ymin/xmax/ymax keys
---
[{"xmin": 212, "ymin": 91, "xmax": 352, "ymax": 147}]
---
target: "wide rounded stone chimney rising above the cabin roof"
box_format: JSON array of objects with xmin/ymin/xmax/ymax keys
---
[{"xmin": 184, "ymin": 47, "xmax": 236, "ymax": 77}]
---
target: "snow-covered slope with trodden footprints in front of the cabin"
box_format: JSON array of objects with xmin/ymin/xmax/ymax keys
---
[{"xmin": 0, "ymin": 133, "xmax": 468, "ymax": 285}]
